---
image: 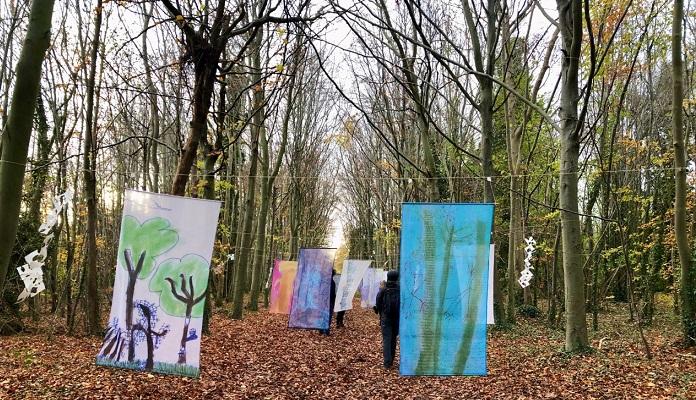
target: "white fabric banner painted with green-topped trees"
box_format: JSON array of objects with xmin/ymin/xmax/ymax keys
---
[{"xmin": 97, "ymin": 190, "xmax": 220, "ymax": 377}]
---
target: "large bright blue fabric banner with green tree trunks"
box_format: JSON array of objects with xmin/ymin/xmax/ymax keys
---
[{"xmin": 399, "ymin": 203, "xmax": 494, "ymax": 375}]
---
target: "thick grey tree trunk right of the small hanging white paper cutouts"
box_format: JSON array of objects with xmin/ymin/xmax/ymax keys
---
[{"xmin": 556, "ymin": 0, "xmax": 589, "ymax": 351}]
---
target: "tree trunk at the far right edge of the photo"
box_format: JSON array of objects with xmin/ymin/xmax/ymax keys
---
[{"xmin": 672, "ymin": 0, "xmax": 696, "ymax": 346}]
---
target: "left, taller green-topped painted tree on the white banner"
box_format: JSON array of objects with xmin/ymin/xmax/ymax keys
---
[{"xmin": 118, "ymin": 215, "xmax": 179, "ymax": 362}]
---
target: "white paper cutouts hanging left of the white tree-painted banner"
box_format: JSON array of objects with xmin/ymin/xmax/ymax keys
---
[{"xmin": 17, "ymin": 189, "xmax": 73, "ymax": 303}]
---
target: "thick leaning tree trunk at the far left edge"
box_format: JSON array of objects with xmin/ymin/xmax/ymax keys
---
[{"xmin": 0, "ymin": 0, "xmax": 54, "ymax": 298}]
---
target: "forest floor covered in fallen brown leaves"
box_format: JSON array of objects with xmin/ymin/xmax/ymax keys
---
[{"xmin": 0, "ymin": 298, "xmax": 696, "ymax": 399}]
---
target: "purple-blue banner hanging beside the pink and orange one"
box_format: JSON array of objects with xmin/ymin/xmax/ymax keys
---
[{"xmin": 288, "ymin": 248, "xmax": 336, "ymax": 329}]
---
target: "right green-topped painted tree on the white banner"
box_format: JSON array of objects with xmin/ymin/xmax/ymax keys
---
[{"xmin": 150, "ymin": 254, "xmax": 209, "ymax": 364}]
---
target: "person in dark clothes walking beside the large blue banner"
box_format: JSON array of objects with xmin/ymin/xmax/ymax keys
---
[{"xmin": 373, "ymin": 271, "xmax": 401, "ymax": 368}]
